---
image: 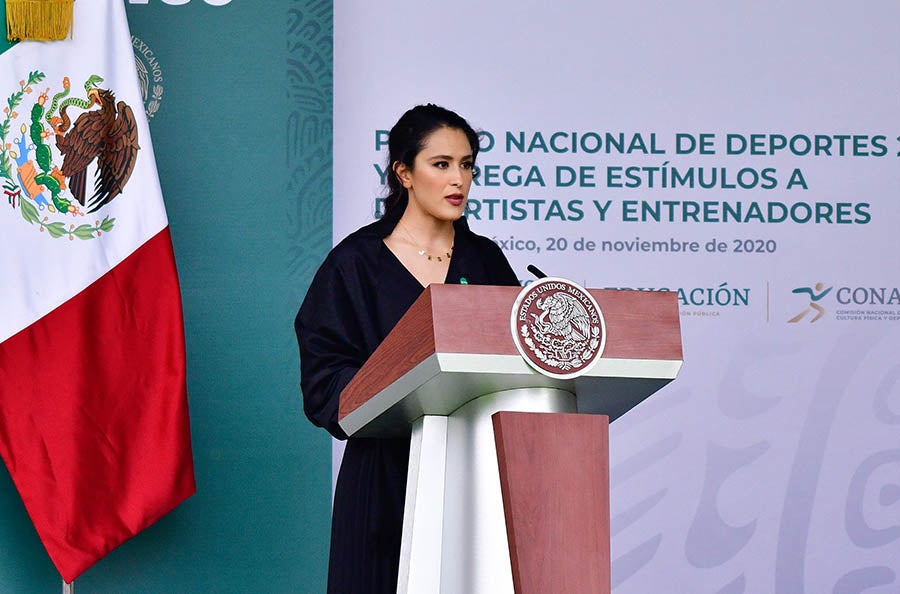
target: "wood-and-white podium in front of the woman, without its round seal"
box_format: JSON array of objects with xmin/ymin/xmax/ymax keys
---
[{"xmin": 339, "ymin": 285, "xmax": 682, "ymax": 594}]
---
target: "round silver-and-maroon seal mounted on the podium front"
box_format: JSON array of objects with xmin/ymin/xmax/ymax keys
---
[{"xmin": 510, "ymin": 278, "xmax": 606, "ymax": 379}]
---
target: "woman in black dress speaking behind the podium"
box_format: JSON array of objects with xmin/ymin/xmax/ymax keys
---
[{"xmin": 295, "ymin": 104, "xmax": 519, "ymax": 594}]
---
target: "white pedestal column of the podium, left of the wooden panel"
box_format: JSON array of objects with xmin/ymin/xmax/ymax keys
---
[{"xmin": 397, "ymin": 388, "xmax": 576, "ymax": 594}]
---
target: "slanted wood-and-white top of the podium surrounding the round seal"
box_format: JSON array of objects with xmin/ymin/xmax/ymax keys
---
[{"xmin": 338, "ymin": 284, "xmax": 682, "ymax": 437}]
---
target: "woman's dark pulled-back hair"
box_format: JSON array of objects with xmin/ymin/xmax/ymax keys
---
[{"xmin": 384, "ymin": 103, "xmax": 478, "ymax": 213}]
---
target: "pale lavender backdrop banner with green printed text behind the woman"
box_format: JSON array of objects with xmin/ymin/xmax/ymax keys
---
[{"xmin": 334, "ymin": 0, "xmax": 900, "ymax": 594}]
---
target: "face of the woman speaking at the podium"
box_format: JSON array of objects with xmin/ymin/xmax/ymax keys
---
[{"xmin": 395, "ymin": 128, "xmax": 474, "ymax": 222}]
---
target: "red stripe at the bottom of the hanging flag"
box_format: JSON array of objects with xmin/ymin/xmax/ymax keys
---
[{"xmin": 0, "ymin": 228, "xmax": 195, "ymax": 582}]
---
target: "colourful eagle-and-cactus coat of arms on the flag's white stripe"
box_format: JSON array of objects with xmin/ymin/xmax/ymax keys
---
[{"xmin": 0, "ymin": 71, "xmax": 140, "ymax": 240}]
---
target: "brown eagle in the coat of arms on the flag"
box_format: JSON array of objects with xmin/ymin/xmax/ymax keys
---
[{"xmin": 50, "ymin": 77, "xmax": 140, "ymax": 212}]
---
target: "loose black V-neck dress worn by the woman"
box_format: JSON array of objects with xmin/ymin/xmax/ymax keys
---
[{"xmin": 295, "ymin": 204, "xmax": 519, "ymax": 594}]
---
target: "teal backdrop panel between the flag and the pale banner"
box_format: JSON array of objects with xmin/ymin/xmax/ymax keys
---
[{"xmin": 0, "ymin": 0, "xmax": 333, "ymax": 594}]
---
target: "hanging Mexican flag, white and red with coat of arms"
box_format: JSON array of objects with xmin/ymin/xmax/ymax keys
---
[{"xmin": 0, "ymin": 0, "xmax": 195, "ymax": 582}]
